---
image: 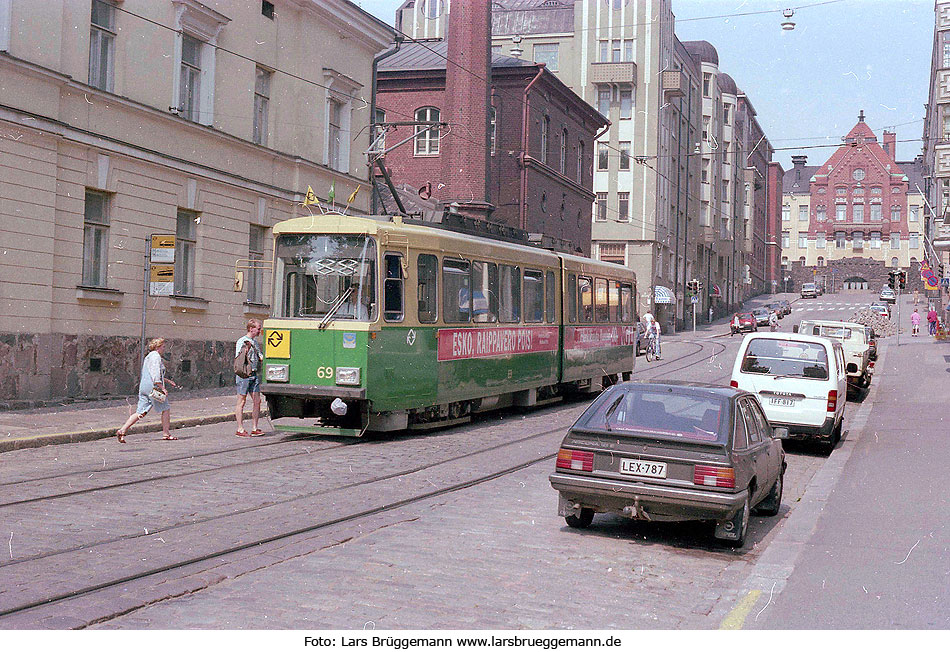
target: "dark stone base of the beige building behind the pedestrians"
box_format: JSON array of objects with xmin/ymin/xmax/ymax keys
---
[{"xmin": 0, "ymin": 333, "xmax": 234, "ymax": 409}]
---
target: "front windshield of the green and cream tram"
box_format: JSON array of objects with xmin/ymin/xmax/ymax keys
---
[{"xmin": 274, "ymin": 234, "xmax": 377, "ymax": 321}]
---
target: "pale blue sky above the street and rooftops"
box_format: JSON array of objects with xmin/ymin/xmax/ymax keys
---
[{"xmin": 356, "ymin": 0, "xmax": 934, "ymax": 169}]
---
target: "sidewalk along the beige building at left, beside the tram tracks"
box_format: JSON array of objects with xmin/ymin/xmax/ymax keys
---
[{"xmin": 0, "ymin": 387, "xmax": 267, "ymax": 453}]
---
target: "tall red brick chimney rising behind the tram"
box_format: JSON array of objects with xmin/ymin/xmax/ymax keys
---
[{"xmin": 439, "ymin": 0, "xmax": 494, "ymax": 219}]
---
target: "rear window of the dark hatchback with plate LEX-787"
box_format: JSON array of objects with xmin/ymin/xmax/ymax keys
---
[{"xmin": 574, "ymin": 389, "xmax": 727, "ymax": 444}]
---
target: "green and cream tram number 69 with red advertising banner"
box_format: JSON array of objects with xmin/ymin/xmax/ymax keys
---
[{"xmin": 261, "ymin": 213, "xmax": 638, "ymax": 437}]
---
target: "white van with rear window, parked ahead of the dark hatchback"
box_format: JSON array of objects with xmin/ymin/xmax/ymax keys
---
[{"xmin": 729, "ymin": 333, "xmax": 848, "ymax": 453}]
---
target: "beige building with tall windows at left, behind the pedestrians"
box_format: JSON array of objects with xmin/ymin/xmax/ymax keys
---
[{"xmin": 0, "ymin": 0, "xmax": 392, "ymax": 404}]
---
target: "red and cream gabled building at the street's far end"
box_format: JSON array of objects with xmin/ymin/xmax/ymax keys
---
[{"xmin": 781, "ymin": 116, "xmax": 927, "ymax": 291}]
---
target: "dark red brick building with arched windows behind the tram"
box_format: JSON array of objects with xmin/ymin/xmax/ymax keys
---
[{"xmin": 377, "ymin": 41, "xmax": 607, "ymax": 255}]
